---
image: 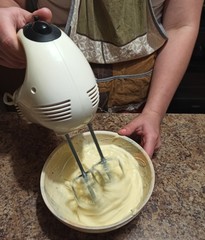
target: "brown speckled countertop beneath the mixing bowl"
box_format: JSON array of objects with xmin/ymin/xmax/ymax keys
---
[{"xmin": 0, "ymin": 112, "xmax": 205, "ymax": 240}]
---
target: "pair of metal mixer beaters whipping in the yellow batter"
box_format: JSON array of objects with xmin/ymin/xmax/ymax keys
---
[{"xmin": 65, "ymin": 123, "xmax": 124, "ymax": 203}]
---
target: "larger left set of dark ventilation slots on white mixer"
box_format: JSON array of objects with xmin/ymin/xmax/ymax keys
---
[{"xmin": 35, "ymin": 100, "xmax": 72, "ymax": 121}]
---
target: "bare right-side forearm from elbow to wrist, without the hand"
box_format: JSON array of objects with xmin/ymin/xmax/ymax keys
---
[{"xmin": 145, "ymin": 26, "xmax": 201, "ymax": 118}]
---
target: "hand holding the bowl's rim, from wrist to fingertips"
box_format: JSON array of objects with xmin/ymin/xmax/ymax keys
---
[{"xmin": 118, "ymin": 112, "xmax": 161, "ymax": 157}]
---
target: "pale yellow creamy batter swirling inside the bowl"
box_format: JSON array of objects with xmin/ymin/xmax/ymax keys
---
[{"xmin": 42, "ymin": 134, "xmax": 151, "ymax": 227}]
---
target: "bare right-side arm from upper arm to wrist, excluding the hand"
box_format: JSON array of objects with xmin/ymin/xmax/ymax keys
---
[{"xmin": 144, "ymin": 0, "xmax": 203, "ymax": 119}]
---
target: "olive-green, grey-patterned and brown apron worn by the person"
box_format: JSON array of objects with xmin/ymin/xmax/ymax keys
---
[{"xmin": 28, "ymin": 0, "xmax": 167, "ymax": 112}]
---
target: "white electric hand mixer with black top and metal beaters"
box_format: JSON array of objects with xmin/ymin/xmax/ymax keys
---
[{"xmin": 4, "ymin": 18, "xmax": 121, "ymax": 200}]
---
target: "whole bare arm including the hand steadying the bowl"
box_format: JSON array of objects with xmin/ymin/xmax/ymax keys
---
[{"xmin": 119, "ymin": 0, "xmax": 203, "ymax": 157}]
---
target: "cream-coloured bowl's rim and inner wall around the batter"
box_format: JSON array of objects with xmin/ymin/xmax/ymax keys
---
[{"xmin": 40, "ymin": 131, "xmax": 155, "ymax": 233}]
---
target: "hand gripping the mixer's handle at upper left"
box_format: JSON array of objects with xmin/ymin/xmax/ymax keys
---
[{"xmin": 0, "ymin": 7, "xmax": 52, "ymax": 69}]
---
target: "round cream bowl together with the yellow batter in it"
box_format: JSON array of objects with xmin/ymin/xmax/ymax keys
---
[{"xmin": 40, "ymin": 131, "xmax": 155, "ymax": 233}]
